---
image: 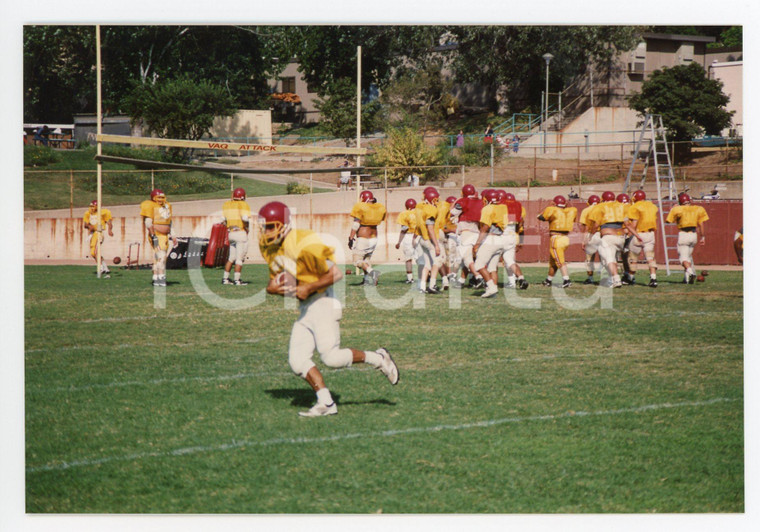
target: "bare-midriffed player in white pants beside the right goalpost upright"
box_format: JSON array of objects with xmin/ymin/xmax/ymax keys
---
[{"xmin": 348, "ymin": 190, "xmax": 385, "ymax": 285}]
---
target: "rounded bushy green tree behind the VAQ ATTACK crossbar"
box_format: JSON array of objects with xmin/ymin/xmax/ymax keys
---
[{"xmin": 125, "ymin": 76, "xmax": 236, "ymax": 159}]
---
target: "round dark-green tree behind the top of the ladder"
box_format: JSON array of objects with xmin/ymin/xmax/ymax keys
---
[{"xmin": 629, "ymin": 63, "xmax": 733, "ymax": 148}]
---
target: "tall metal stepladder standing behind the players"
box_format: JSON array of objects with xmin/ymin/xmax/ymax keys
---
[{"xmin": 623, "ymin": 114, "xmax": 679, "ymax": 276}]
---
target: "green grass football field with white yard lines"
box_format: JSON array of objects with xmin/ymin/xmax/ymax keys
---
[{"xmin": 24, "ymin": 265, "xmax": 744, "ymax": 514}]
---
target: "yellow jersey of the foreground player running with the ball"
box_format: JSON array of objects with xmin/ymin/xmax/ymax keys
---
[{"xmin": 259, "ymin": 229, "xmax": 335, "ymax": 292}]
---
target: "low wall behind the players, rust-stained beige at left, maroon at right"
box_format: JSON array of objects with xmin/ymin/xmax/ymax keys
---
[{"xmin": 24, "ymin": 200, "xmax": 743, "ymax": 265}]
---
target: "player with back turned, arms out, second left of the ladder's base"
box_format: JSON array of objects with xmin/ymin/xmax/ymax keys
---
[{"xmin": 588, "ymin": 190, "xmax": 641, "ymax": 288}]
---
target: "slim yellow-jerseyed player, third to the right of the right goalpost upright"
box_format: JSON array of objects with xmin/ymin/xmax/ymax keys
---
[{"xmin": 414, "ymin": 187, "xmax": 443, "ymax": 294}]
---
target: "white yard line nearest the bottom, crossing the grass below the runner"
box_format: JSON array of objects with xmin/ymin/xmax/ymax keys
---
[{"xmin": 26, "ymin": 397, "xmax": 739, "ymax": 474}]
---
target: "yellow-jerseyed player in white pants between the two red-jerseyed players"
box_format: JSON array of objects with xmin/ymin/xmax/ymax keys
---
[{"xmin": 472, "ymin": 189, "xmax": 516, "ymax": 298}]
